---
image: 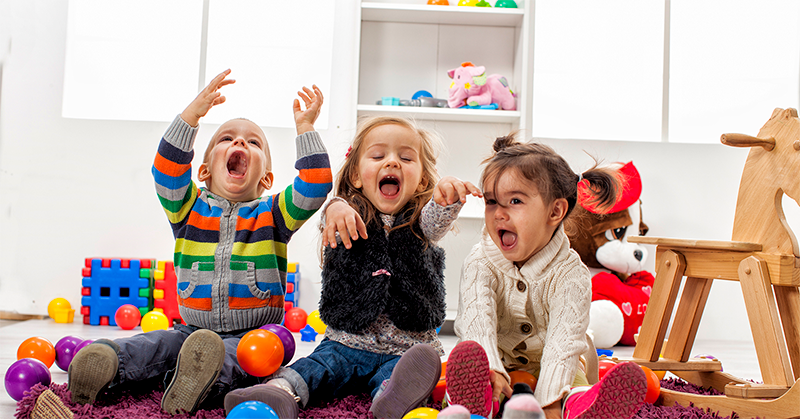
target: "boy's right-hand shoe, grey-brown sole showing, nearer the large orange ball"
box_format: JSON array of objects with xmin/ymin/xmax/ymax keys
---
[{"xmin": 161, "ymin": 329, "xmax": 225, "ymax": 415}]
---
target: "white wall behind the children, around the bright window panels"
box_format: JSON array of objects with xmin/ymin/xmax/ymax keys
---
[{"xmin": 0, "ymin": 0, "xmax": 792, "ymax": 340}]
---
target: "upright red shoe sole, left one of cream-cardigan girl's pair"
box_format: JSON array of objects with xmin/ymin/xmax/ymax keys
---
[{"xmin": 445, "ymin": 340, "xmax": 493, "ymax": 418}]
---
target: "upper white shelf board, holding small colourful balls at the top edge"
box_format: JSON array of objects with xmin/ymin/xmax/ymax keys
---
[{"xmin": 361, "ymin": 2, "xmax": 525, "ymax": 27}]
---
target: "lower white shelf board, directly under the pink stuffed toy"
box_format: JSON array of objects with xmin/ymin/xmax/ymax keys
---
[{"xmin": 358, "ymin": 104, "xmax": 520, "ymax": 124}]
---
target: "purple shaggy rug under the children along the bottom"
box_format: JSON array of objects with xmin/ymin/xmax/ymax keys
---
[{"xmin": 14, "ymin": 378, "xmax": 738, "ymax": 419}]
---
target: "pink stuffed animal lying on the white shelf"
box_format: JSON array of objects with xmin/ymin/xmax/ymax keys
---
[{"xmin": 447, "ymin": 62, "xmax": 517, "ymax": 111}]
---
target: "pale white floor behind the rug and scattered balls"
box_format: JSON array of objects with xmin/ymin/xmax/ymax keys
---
[{"xmin": 0, "ymin": 319, "xmax": 761, "ymax": 418}]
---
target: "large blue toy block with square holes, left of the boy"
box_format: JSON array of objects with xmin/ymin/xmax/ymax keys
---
[{"xmin": 81, "ymin": 259, "xmax": 150, "ymax": 326}]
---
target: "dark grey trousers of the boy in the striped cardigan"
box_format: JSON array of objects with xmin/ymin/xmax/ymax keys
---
[{"xmin": 109, "ymin": 324, "xmax": 257, "ymax": 400}]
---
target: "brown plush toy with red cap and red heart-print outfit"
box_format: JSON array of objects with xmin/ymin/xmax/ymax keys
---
[{"xmin": 566, "ymin": 162, "xmax": 654, "ymax": 348}]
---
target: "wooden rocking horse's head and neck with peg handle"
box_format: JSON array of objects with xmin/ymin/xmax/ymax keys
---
[{"xmin": 720, "ymin": 108, "xmax": 800, "ymax": 257}]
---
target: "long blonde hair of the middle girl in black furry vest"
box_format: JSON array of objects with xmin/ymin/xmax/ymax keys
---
[{"xmin": 334, "ymin": 116, "xmax": 442, "ymax": 238}]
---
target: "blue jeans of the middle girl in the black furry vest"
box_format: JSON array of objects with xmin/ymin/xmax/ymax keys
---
[{"xmin": 270, "ymin": 338, "xmax": 400, "ymax": 407}]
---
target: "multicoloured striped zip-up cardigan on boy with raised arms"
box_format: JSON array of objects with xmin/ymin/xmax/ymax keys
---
[{"xmin": 152, "ymin": 115, "xmax": 332, "ymax": 332}]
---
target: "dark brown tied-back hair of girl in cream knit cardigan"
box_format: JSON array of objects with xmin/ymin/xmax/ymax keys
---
[{"xmin": 481, "ymin": 132, "xmax": 619, "ymax": 223}]
